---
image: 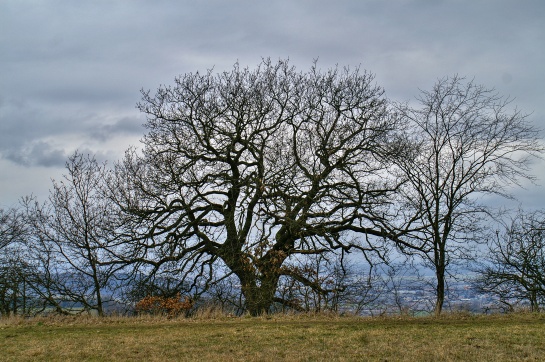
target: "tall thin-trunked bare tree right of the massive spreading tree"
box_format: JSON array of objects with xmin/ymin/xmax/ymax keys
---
[{"xmin": 397, "ymin": 76, "xmax": 543, "ymax": 314}]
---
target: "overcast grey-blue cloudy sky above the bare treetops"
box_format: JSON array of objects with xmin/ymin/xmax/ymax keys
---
[{"xmin": 0, "ymin": 0, "xmax": 545, "ymax": 208}]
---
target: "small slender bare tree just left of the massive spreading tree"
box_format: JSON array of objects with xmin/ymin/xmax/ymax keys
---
[{"xmin": 26, "ymin": 152, "xmax": 123, "ymax": 316}]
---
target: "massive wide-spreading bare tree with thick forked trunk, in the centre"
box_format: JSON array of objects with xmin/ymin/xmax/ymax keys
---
[{"xmin": 111, "ymin": 60, "xmax": 398, "ymax": 314}]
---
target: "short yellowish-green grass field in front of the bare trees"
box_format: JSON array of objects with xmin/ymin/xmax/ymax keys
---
[{"xmin": 0, "ymin": 314, "xmax": 545, "ymax": 361}]
